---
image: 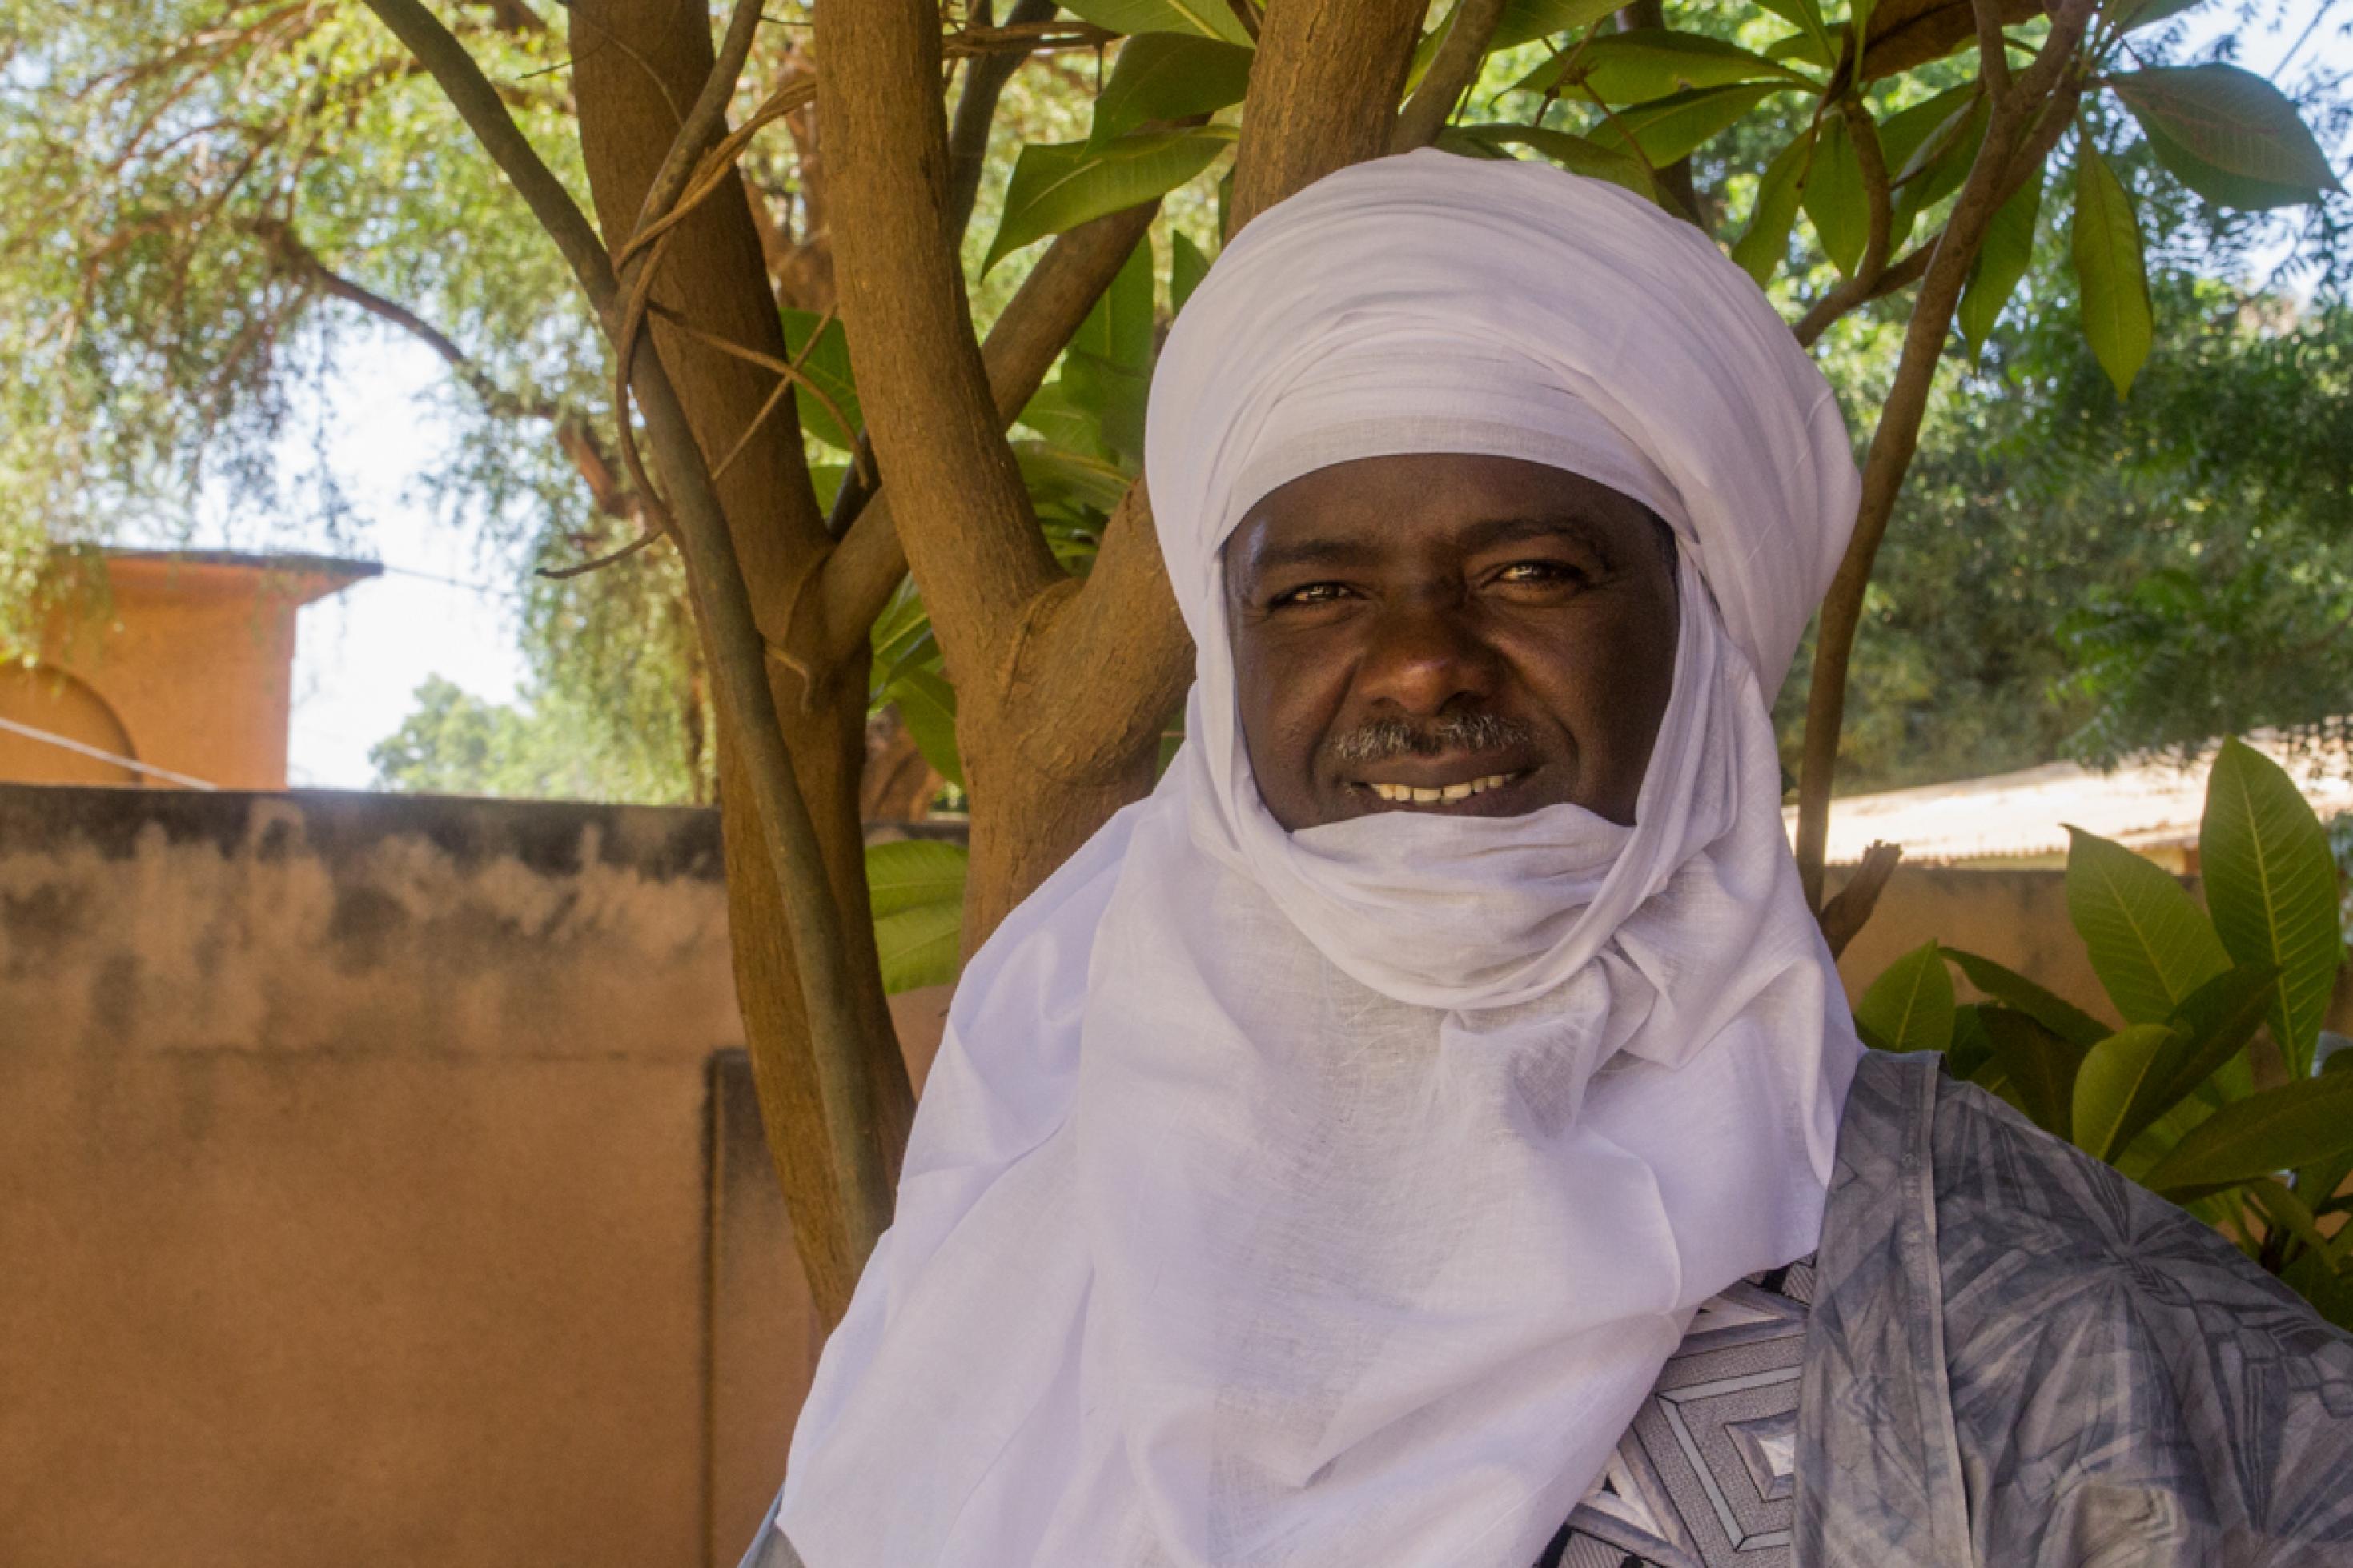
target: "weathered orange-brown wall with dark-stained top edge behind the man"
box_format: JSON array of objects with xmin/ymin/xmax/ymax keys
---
[{"xmin": 0, "ymin": 785, "xmax": 2334, "ymax": 1568}]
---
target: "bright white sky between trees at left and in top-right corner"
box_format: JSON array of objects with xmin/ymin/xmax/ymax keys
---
[{"xmin": 221, "ymin": 0, "xmax": 2353, "ymax": 790}]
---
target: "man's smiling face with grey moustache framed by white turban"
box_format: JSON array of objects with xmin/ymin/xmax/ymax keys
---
[{"xmin": 1223, "ymin": 454, "xmax": 1676, "ymax": 832}]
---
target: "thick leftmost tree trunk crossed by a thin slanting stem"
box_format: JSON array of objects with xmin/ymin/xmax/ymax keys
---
[{"xmin": 572, "ymin": 0, "xmax": 913, "ymax": 1324}]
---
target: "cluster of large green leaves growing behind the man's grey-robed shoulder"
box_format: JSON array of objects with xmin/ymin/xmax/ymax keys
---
[{"xmin": 1854, "ymin": 740, "xmax": 2353, "ymax": 1325}]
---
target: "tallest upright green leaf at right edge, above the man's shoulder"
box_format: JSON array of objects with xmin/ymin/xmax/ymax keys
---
[{"xmin": 2198, "ymin": 738, "xmax": 2343, "ymax": 1077}]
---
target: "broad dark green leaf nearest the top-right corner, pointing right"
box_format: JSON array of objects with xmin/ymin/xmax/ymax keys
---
[{"xmin": 2108, "ymin": 63, "xmax": 2343, "ymax": 207}]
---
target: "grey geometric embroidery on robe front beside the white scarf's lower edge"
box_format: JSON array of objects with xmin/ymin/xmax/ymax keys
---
[{"xmin": 1536, "ymin": 1257, "xmax": 1814, "ymax": 1568}]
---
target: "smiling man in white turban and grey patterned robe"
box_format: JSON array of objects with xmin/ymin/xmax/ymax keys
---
[{"xmin": 749, "ymin": 153, "xmax": 2353, "ymax": 1568}]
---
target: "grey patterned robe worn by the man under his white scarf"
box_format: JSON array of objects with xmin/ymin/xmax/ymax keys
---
[{"xmin": 744, "ymin": 1053, "xmax": 2353, "ymax": 1568}]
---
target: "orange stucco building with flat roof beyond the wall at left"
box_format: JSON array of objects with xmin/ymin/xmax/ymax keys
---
[{"xmin": 0, "ymin": 550, "xmax": 381, "ymax": 790}]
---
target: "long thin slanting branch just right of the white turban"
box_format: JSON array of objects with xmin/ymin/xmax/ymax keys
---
[{"xmin": 1797, "ymin": 0, "xmax": 2094, "ymax": 910}]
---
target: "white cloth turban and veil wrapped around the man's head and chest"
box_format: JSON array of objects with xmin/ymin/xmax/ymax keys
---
[{"xmin": 779, "ymin": 153, "xmax": 1857, "ymax": 1568}]
